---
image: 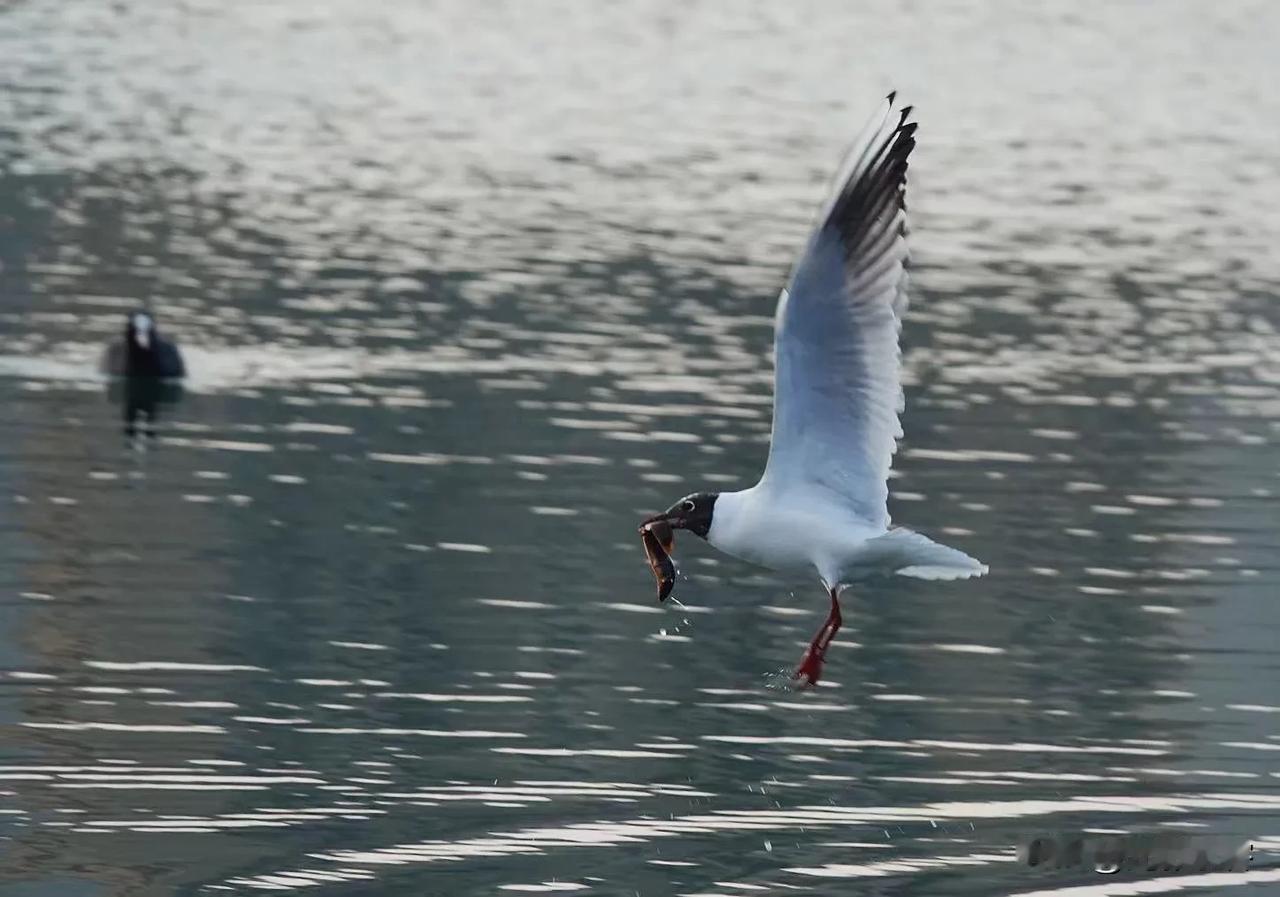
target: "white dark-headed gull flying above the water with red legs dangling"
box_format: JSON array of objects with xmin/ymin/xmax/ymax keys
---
[{"xmin": 645, "ymin": 93, "xmax": 987, "ymax": 685}]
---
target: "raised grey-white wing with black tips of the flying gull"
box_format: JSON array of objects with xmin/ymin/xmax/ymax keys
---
[{"xmin": 762, "ymin": 93, "xmax": 915, "ymax": 527}]
